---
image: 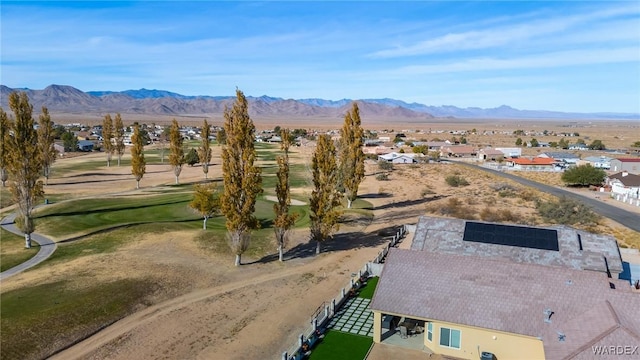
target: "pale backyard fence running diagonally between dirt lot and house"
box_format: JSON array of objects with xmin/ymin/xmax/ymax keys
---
[{"xmin": 282, "ymin": 225, "xmax": 407, "ymax": 360}]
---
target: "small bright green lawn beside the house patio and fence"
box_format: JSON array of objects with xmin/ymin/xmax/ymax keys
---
[{"xmin": 309, "ymin": 330, "xmax": 373, "ymax": 360}]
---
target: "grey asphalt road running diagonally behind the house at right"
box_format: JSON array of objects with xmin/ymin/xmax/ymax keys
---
[{"xmin": 455, "ymin": 161, "xmax": 640, "ymax": 232}]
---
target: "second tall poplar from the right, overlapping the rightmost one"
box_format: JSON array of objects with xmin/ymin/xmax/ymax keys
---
[{"xmin": 309, "ymin": 135, "xmax": 341, "ymax": 254}]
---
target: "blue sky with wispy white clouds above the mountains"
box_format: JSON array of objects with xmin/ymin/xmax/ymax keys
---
[{"xmin": 0, "ymin": 0, "xmax": 640, "ymax": 113}]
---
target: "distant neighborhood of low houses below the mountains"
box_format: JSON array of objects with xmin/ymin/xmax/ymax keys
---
[{"xmin": 50, "ymin": 119, "xmax": 640, "ymax": 210}]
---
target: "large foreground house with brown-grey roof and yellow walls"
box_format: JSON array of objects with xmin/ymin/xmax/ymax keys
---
[{"xmin": 370, "ymin": 217, "xmax": 640, "ymax": 360}]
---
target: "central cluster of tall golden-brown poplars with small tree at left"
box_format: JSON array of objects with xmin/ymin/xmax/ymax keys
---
[{"xmin": 211, "ymin": 90, "xmax": 364, "ymax": 266}]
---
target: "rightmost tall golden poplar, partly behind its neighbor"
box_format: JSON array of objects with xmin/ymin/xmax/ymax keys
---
[{"xmin": 340, "ymin": 102, "xmax": 364, "ymax": 209}]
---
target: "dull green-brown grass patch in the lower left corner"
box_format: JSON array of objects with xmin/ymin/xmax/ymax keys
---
[{"xmin": 0, "ymin": 279, "xmax": 157, "ymax": 359}]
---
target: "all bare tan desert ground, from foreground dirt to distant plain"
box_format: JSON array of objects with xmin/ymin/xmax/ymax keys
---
[{"xmin": 2, "ymin": 116, "xmax": 640, "ymax": 359}]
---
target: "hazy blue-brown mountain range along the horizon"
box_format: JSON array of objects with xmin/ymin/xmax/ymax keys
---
[{"xmin": 0, "ymin": 85, "xmax": 640, "ymax": 120}]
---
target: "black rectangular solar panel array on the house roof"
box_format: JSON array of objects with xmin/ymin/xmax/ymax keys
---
[{"xmin": 463, "ymin": 221, "xmax": 559, "ymax": 251}]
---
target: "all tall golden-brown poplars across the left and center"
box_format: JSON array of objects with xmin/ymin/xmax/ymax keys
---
[{"xmin": 0, "ymin": 90, "xmax": 364, "ymax": 265}]
